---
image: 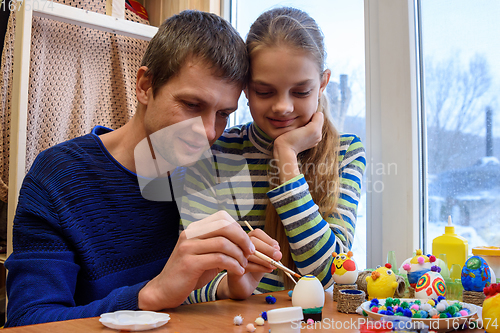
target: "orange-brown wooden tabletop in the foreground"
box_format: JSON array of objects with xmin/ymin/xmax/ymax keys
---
[{"xmin": 1, "ymin": 291, "xmax": 484, "ymax": 333}]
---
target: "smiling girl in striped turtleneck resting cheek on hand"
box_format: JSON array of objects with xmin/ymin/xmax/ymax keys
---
[{"xmin": 181, "ymin": 8, "xmax": 366, "ymax": 293}]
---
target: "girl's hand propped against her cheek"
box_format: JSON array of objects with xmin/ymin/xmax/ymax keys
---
[{"xmin": 274, "ymin": 112, "xmax": 324, "ymax": 155}]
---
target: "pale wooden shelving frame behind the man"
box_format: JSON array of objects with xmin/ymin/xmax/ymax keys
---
[{"xmin": 0, "ymin": 0, "xmax": 223, "ymax": 318}]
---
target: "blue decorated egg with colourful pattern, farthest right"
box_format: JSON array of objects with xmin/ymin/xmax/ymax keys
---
[{"xmin": 461, "ymin": 256, "xmax": 491, "ymax": 292}]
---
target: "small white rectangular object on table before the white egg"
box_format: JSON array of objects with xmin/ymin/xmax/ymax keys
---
[{"xmin": 267, "ymin": 306, "xmax": 304, "ymax": 333}]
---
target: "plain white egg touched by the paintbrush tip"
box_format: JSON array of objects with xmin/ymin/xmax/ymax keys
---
[{"xmin": 292, "ymin": 275, "xmax": 325, "ymax": 309}]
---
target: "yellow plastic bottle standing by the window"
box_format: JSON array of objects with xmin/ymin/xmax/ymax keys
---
[{"xmin": 432, "ymin": 216, "xmax": 469, "ymax": 269}]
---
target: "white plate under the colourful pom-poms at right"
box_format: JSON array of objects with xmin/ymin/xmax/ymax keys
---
[{"xmin": 361, "ymin": 298, "xmax": 476, "ymax": 332}]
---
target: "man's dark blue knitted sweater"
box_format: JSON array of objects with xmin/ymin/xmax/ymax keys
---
[{"xmin": 5, "ymin": 127, "xmax": 181, "ymax": 327}]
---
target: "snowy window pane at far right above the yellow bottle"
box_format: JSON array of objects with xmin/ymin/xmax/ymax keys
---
[{"xmin": 420, "ymin": 0, "xmax": 500, "ymax": 253}]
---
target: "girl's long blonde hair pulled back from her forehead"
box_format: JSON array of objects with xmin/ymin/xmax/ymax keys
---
[{"xmin": 246, "ymin": 7, "xmax": 340, "ymax": 289}]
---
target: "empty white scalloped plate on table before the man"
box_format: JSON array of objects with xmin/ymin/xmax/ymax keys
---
[{"xmin": 99, "ymin": 310, "xmax": 170, "ymax": 331}]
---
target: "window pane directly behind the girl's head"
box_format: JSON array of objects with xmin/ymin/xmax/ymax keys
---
[{"xmin": 232, "ymin": 0, "xmax": 367, "ymax": 269}]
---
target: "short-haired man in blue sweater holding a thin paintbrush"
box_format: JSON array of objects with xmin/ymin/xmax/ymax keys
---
[{"xmin": 5, "ymin": 11, "xmax": 281, "ymax": 327}]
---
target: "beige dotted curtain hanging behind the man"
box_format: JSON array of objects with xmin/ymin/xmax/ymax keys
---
[{"xmin": 0, "ymin": 0, "xmax": 149, "ymax": 202}]
